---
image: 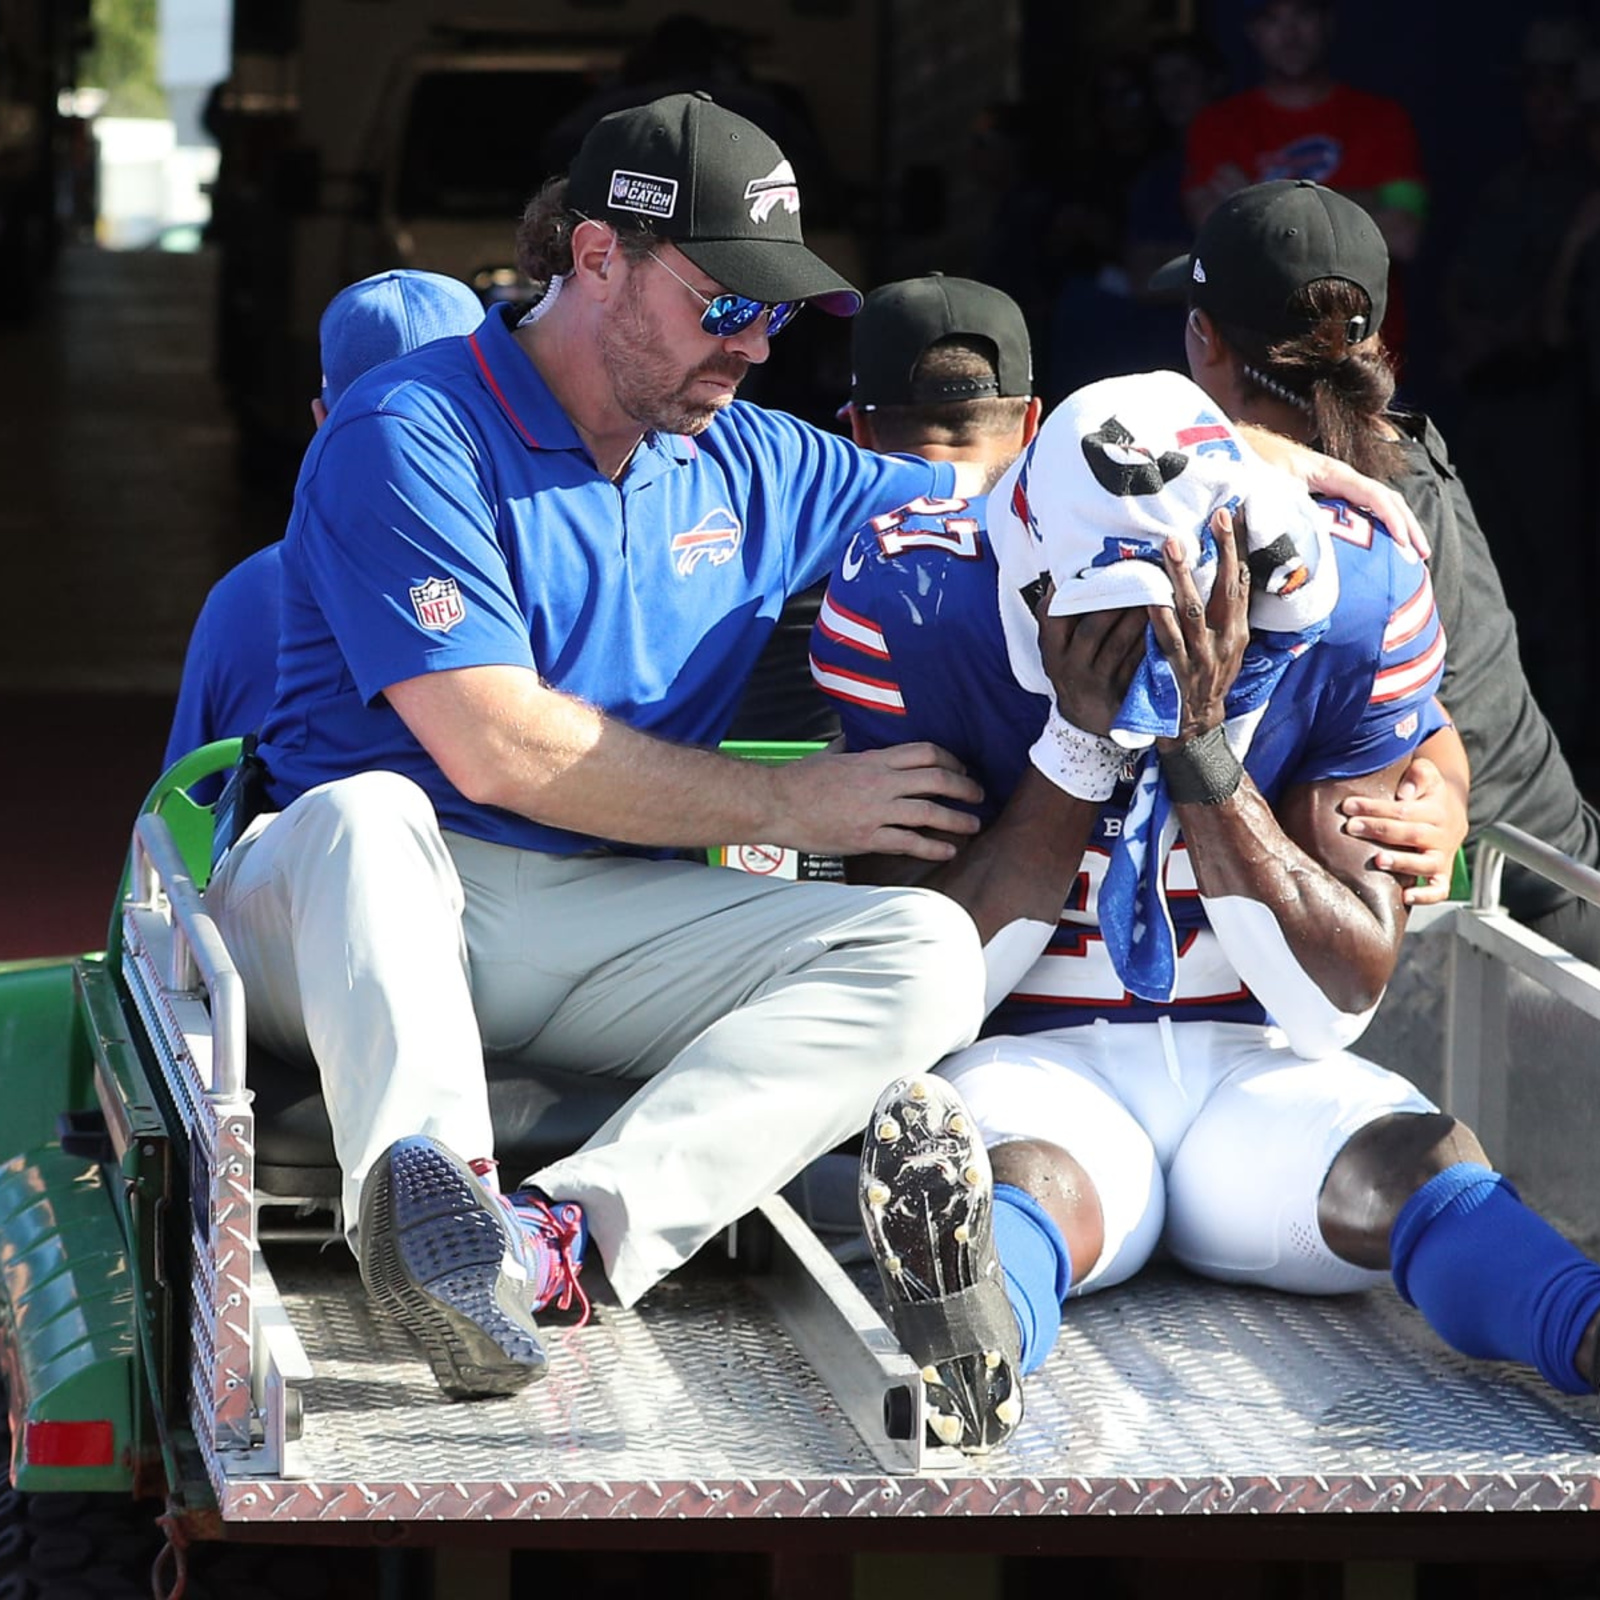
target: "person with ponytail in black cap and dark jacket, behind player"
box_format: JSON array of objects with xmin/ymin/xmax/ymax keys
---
[{"xmin": 1152, "ymin": 181, "xmax": 1600, "ymax": 963}]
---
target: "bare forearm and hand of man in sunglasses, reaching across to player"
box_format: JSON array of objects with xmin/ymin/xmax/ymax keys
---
[{"xmin": 384, "ymin": 667, "xmax": 981, "ymax": 861}]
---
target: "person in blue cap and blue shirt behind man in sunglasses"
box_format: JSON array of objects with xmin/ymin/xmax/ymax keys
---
[{"xmin": 165, "ymin": 267, "xmax": 483, "ymax": 802}]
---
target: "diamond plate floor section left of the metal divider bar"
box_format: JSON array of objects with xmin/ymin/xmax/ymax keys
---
[{"xmin": 274, "ymin": 1251, "xmax": 874, "ymax": 1482}]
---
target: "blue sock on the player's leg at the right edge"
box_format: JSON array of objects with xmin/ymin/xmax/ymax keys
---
[{"xmin": 1389, "ymin": 1162, "xmax": 1600, "ymax": 1395}]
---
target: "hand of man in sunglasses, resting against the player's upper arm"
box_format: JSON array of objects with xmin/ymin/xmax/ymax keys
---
[{"xmin": 771, "ymin": 741, "xmax": 984, "ymax": 861}]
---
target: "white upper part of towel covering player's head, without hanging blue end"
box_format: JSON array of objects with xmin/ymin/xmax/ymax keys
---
[{"xmin": 989, "ymin": 371, "xmax": 1339, "ymax": 707}]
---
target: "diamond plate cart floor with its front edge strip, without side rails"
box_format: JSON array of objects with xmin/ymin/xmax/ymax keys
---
[{"xmin": 209, "ymin": 1250, "xmax": 1600, "ymax": 1522}]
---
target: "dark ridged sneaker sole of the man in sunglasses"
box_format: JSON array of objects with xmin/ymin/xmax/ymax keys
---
[{"xmin": 362, "ymin": 1139, "xmax": 549, "ymax": 1400}]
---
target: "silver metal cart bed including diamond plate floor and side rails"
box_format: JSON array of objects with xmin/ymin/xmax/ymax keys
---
[{"xmin": 130, "ymin": 818, "xmax": 1600, "ymax": 1525}]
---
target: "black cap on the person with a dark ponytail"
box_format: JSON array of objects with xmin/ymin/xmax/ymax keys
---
[{"xmin": 1150, "ymin": 178, "xmax": 1389, "ymax": 346}]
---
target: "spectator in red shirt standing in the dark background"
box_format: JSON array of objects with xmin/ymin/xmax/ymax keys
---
[{"xmin": 1184, "ymin": 0, "xmax": 1427, "ymax": 268}]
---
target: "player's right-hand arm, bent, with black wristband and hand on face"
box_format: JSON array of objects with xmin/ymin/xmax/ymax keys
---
[{"xmin": 1150, "ymin": 514, "xmax": 1410, "ymax": 1011}]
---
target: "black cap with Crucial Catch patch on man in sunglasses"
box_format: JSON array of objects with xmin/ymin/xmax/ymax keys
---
[{"xmin": 566, "ymin": 90, "xmax": 861, "ymax": 317}]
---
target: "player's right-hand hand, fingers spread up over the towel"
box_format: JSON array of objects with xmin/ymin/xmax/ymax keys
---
[{"xmin": 1147, "ymin": 509, "xmax": 1250, "ymax": 744}]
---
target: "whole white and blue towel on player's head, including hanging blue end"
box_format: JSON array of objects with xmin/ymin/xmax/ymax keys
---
[{"xmin": 989, "ymin": 373, "xmax": 1339, "ymax": 1002}]
